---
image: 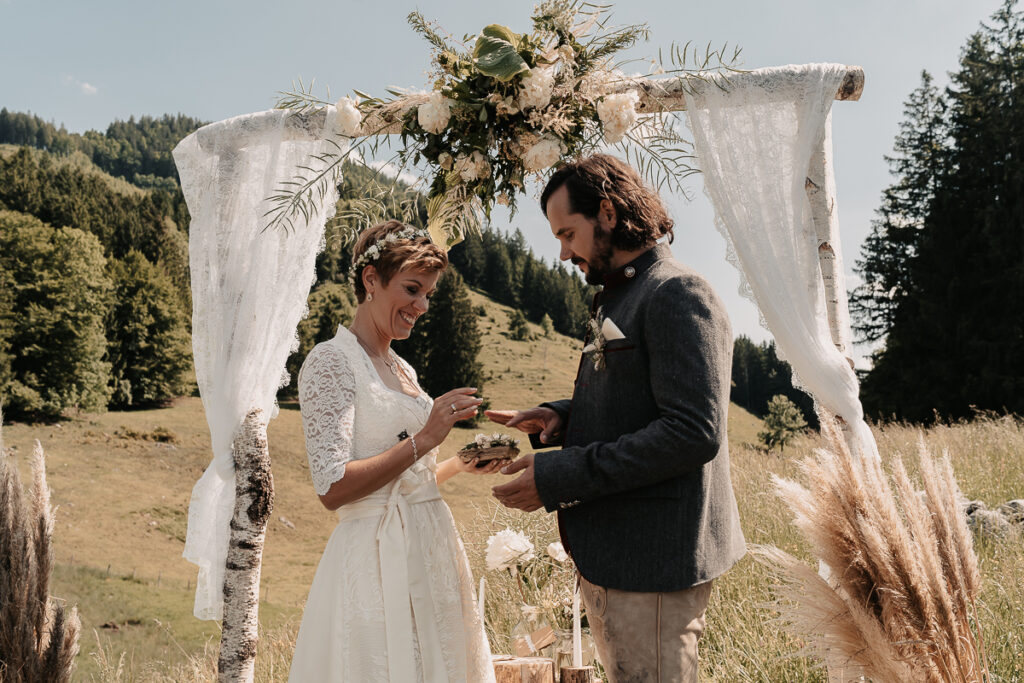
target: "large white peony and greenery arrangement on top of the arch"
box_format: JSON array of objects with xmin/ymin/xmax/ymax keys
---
[{"xmin": 268, "ymin": 0, "xmax": 739, "ymax": 247}]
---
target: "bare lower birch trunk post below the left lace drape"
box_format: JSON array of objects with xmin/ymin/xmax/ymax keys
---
[{"xmin": 217, "ymin": 410, "xmax": 273, "ymax": 683}]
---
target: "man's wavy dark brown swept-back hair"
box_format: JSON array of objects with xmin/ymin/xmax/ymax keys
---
[{"xmin": 541, "ymin": 155, "xmax": 675, "ymax": 251}]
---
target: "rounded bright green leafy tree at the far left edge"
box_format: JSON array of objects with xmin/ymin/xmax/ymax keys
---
[{"xmin": 0, "ymin": 211, "xmax": 111, "ymax": 417}]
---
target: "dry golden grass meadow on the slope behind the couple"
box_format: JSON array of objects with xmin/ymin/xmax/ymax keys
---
[{"xmin": 3, "ymin": 288, "xmax": 1024, "ymax": 681}]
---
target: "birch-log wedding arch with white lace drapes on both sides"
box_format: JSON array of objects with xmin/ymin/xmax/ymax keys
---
[{"xmin": 174, "ymin": 63, "xmax": 864, "ymax": 680}]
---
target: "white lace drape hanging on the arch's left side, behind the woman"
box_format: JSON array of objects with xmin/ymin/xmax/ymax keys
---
[{"xmin": 174, "ymin": 108, "xmax": 343, "ymax": 620}]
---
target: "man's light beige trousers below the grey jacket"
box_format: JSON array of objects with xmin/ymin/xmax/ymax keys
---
[{"xmin": 580, "ymin": 577, "xmax": 712, "ymax": 683}]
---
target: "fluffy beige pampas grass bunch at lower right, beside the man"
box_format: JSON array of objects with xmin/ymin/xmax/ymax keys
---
[{"xmin": 752, "ymin": 416, "xmax": 988, "ymax": 683}]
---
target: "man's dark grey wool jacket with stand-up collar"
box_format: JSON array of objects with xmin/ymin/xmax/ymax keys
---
[{"xmin": 530, "ymin": 244, "xmax": 745, "ymax": 592}]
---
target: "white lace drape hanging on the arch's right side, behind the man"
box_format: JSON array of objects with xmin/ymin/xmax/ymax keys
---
[{"xmin": 686, "ymin": 65, "xmax": 878, "ymax": 457}]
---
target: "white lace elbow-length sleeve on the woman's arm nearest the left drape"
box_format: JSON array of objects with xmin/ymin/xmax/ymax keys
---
[{"xmin": 299, "ymin": 344, "xmax": 355, "ymax": 496}]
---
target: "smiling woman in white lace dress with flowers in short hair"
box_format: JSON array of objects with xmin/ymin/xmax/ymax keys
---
[{"xmin": 289, "ymin": 220, "xmax": 499, "ymax": 683}]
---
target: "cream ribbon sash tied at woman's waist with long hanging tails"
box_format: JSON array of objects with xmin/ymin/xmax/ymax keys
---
[{"xmin": 338, "ymin": 477, "xmax": 449, "ymax": 683}]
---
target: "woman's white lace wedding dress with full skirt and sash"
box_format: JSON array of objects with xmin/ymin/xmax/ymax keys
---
[{"xmin": 289, "ymin": 327, "xmax": 495, "ymax": 683}]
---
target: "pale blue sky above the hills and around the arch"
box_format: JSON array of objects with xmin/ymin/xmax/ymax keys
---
[{"xmin": 0, "ymin": 0, "xmax": 999, "ymax": 360}]
